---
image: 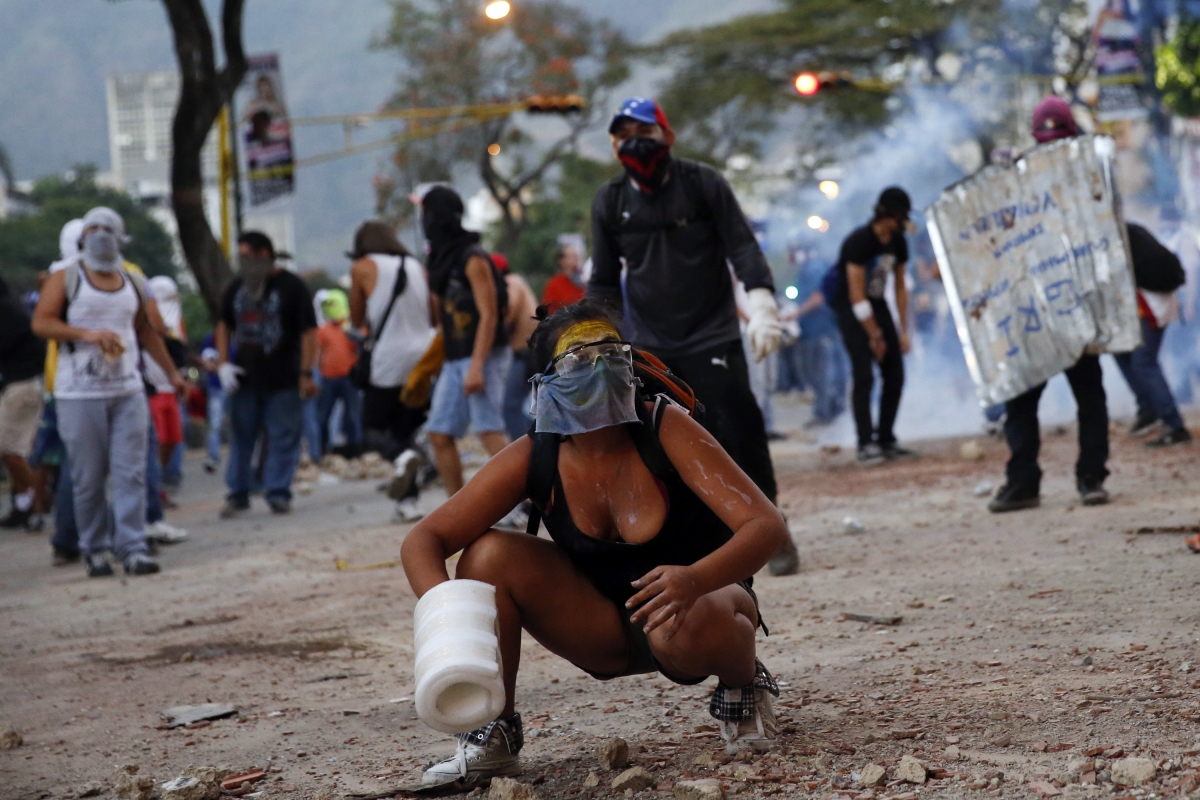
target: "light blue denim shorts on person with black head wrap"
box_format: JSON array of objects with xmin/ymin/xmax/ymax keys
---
[{"xmin": 425, "ymin": 347, "xmax": 512, "ymax": 439}]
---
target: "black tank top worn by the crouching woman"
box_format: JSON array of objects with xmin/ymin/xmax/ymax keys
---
[{"xmin": 529, "ymin": 397, "xmax": 733, "ymax": 608}]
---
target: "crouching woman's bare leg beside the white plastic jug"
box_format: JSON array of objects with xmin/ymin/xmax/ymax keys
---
[{"xmin": 455, "ymin": 530, "xmax": 633, "ymax": 716}]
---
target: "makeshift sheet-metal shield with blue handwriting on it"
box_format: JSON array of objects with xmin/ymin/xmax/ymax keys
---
[{"xmin": 925, "ymin": 136, "xmax": 1141, "ymax": 407}]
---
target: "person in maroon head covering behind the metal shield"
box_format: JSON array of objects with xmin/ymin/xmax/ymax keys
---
[{"xmin": 988, "ymin": 97, "xmax": 1109, "ymax": 513}]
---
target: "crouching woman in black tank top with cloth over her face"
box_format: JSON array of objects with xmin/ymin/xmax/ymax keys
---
[{"xmin": 402, "ymin": 301, "xmax": 787, "ymax": 786}]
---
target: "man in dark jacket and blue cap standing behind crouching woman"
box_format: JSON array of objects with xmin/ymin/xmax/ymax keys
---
[{"xmin": 588, "ymin": 97, "xmax": 798, "ymax": 575}]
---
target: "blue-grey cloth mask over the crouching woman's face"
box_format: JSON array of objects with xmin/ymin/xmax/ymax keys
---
[{"xmin": 532, "ymin": 356, "xmax": 638, "ymax": 437}]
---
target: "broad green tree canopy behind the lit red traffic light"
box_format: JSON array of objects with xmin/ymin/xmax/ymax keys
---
[{"xmin": 650, "ymin": 0, "xmax": 1087, "ymax": 163}]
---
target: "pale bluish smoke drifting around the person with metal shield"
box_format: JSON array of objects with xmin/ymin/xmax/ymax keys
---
[{"xmin": 767, "ymin": 80, "xmax": 1134, "ymax": 445}]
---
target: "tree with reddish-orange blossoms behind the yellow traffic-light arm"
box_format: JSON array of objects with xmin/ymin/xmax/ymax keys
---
[{"xmin": 376, "ymin": 0, "xmax": 631, "ymax": 251}]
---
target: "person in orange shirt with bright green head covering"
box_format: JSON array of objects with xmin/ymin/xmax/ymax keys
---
[{"xmin": 317, "ymin": 289, "xmax": 362, "ymax": 456}]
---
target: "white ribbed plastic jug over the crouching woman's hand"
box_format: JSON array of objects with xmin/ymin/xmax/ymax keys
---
[{"xmin": 413, "ymin": 579, "xmax": 505, "ymax": 733}]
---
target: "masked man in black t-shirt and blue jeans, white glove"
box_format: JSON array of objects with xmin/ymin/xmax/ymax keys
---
[{"xmin": 216, "ymin": 230, "xmax": 317, "ymax": 517}]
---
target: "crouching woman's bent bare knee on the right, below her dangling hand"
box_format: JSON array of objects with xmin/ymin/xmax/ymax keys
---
[{"xmin": 649, "ymin": 585, "xmax": 758, "ymax": 686}]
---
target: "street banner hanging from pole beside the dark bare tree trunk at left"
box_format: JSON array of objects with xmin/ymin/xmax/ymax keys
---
[{"xmin": 238, "ymin": 53, "xmax": 295, "ymax": 205}]
